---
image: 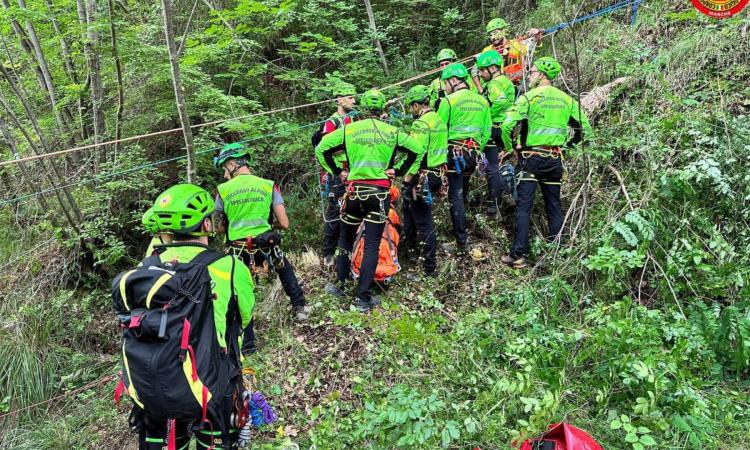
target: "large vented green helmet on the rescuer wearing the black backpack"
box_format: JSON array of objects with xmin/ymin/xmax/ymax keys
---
[{"xmin": 152, "ymin": 184, "xmax": 214, "ymax": 235}]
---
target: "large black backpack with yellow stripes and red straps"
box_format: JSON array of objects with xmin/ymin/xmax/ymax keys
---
[{"xmin": 112, "ymin": 247, "xmax": 240, "ymax": 428}]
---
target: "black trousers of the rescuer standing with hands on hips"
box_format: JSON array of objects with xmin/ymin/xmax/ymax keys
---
[{"xmin": 336, "ymin": 185, "xmax": 390, "ymax": 300}]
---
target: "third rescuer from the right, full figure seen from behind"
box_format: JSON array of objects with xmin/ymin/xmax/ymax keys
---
[{"xmin": 437, "ymin": 63, "xmax": 492, "ymax": 253}]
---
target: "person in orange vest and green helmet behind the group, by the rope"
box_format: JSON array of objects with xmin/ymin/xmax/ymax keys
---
[{"xmin": 473, "ymin": 18, "xmax": 542, "ymax": 92}]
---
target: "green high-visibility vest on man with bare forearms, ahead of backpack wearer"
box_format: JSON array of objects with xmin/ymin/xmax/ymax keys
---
[{"xmin": 218, "ymin": 175, "xmax": 273, "ymax": 241}]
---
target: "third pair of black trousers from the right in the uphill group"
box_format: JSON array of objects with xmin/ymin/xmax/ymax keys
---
[{"xmin": 448, "ymin": 143, "xmax": 477, "ymax": 244}]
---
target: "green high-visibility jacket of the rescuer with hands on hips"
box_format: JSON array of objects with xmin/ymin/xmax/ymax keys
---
[{"xmin": 315, "ymin": 118, "xmax": 424, "ymax": 181}]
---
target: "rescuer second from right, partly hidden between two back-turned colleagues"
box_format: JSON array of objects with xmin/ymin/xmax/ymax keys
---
[{"xmin": 476, "ymin": 50, "xmax": 516, "ymax": 217}]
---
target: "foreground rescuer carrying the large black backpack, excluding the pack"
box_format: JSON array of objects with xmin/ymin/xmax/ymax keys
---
[{"xmin": 134, "ymin": 184, "xmax": 255, "ymax": 450}]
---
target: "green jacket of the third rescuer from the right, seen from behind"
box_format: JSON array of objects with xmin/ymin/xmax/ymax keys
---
[{"xmin": 438, "ymin": 89, "xmax": 492, "ymax": 150}]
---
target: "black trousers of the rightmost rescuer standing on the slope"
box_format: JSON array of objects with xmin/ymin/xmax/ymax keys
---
[{"xmin": 510, "ymin": 155, "xmax": 563, "ymax": 258}]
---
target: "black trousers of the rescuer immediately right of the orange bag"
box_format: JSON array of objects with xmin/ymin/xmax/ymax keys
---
[{"xmin": 401, "ymin": 172, "xmax": 442, "ymax": 275}]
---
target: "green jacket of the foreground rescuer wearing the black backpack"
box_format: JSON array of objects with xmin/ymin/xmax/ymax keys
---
[{"xmin": 147, "ymin": 244, "xmax": 255, "ymax": 348}]
